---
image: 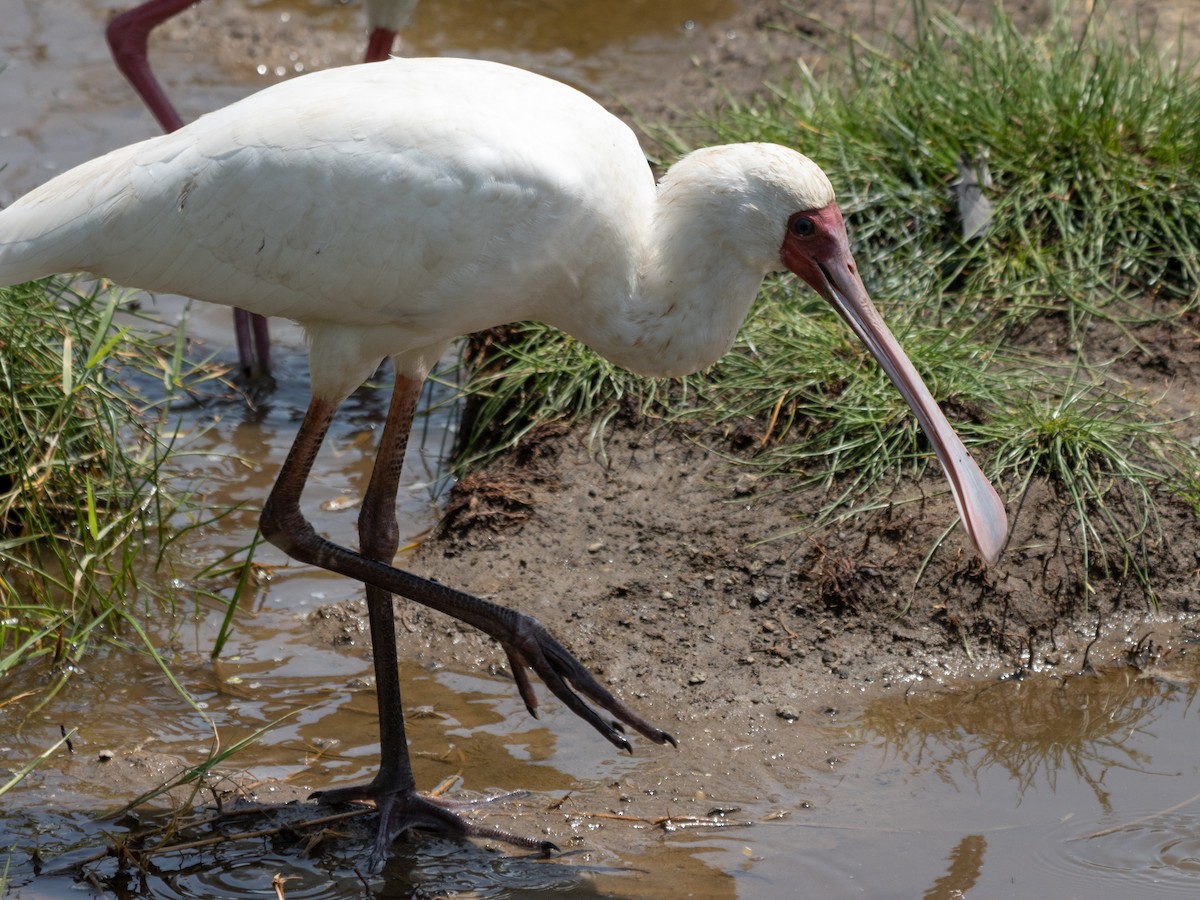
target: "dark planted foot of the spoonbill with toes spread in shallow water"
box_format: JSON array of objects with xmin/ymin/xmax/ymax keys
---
[{"xmin": 308, "ymin": 781, "xmax": 558, "ymax": 871}]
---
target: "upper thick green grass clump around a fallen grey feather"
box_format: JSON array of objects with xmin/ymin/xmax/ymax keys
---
[{"xmin": 700, "ymin": 2, "xmax": 1200, "ymax": 326}]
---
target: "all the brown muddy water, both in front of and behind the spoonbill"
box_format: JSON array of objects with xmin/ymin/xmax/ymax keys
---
[{"xmin": 0, "ymin": 0, "xmax": 1200, "ymax": 899}]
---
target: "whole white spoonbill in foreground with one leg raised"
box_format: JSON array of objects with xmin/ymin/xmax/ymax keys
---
[{"xmin": 0, "ymin": 59, "xmax": 1008, "ymax": 862}]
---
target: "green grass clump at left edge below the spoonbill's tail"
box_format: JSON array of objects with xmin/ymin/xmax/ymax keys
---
[{"xmin": 0, "ymin": 281, "xmax": 225, "ymax": 703}]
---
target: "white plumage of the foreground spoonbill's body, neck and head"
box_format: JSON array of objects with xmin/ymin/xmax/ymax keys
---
[{"xmin": 0, "ymin": 59, "xmax": 833, "ymax": 391}]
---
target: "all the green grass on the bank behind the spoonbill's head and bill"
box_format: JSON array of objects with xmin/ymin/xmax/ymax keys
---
[{"xmin": 453, "ymin": 2, "xmax": 1200, "ymax": 604}]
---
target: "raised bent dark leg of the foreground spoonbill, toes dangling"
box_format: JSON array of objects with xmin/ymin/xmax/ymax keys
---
[{"xmin": 260, "ymin": 397, "xmax": 676, "ymax": 763}]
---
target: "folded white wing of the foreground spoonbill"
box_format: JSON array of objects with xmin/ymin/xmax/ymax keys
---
[{"xmin": 0, "ymin": 60, "xmax": 653, "ymax": 337}]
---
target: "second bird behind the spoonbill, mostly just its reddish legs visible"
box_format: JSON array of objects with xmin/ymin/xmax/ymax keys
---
[{"xmin": 104, "ymin": 0, "xmax": 416, "ymax": 377}]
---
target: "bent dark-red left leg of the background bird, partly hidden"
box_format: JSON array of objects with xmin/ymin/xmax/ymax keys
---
[{"xmin": 104, "ymin": 0, "xmax": 271, "ymax": 382}]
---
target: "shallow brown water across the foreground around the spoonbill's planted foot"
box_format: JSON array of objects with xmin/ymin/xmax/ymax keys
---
[{"xmin": 9, "ymin": 643, "xmax": 1200, "ymax": 898}]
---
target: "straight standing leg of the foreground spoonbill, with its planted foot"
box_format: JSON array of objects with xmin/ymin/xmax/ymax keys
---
[{"xmin": 312, "ymin": 376, "xmax": 557, "ymax": 868}]
